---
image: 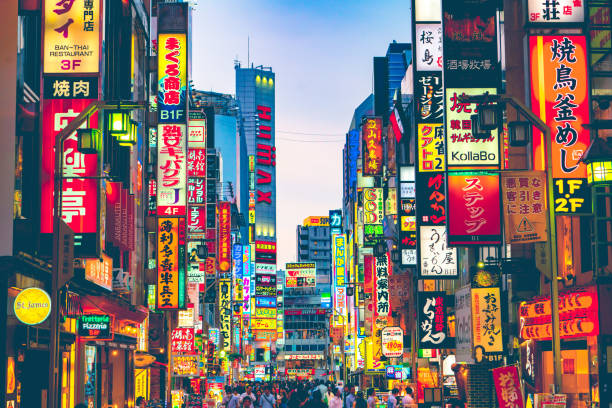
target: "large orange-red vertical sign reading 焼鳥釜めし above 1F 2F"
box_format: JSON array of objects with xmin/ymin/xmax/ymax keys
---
[{"xmin": 529, "ymin": 35, "xmax": 590, "ymax": 179}]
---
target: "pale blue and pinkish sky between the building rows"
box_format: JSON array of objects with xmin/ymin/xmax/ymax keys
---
[{"xmin": 191, "ymin": 0, "xmax": 410, "ymax": 269}]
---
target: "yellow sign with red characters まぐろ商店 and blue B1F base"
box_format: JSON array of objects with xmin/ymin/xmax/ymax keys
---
[{"xmin": 157, "ymin": 33, "xmax": 187, "ymax": 122}]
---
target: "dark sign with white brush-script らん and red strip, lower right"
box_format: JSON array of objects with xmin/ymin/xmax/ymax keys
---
[{"xmin": 417, "ymin": 292, "xmax": 449, "ymax": 349}]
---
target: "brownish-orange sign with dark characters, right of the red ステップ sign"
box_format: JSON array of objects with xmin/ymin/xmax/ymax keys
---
[{"xmin": 502, "ymin": 171, "xmax": 547, "ymax": 244}]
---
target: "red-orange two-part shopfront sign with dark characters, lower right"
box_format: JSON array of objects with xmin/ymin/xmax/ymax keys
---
[{"xmin": 519, "ymin": 286, "xmax": 599, "ymax": 340}]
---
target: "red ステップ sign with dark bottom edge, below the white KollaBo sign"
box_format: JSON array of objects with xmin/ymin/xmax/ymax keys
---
[{"xmin": 448, "ymin": 172, "xmax": 501, "ymax": 246}]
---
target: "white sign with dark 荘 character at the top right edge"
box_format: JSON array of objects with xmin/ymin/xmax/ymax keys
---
[{"xmin": 527, "ymin": 0, "xmax": 586, "ymax": 24}]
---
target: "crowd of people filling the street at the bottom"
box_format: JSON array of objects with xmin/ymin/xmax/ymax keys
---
[{"xmin": 219, "ymin": 380, "xmax": 417, "ymax": 408}]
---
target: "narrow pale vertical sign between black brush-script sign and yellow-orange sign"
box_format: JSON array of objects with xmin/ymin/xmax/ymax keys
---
[{"xmin": 455, "ymin": 285, "xmax": 474, "ymax": 364}]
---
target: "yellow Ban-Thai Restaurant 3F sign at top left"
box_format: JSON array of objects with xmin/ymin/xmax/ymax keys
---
[{"xmin": 43, "ymin": 0, "xmax": 100, "ymax": 74}]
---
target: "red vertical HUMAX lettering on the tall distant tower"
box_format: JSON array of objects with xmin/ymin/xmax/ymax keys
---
[{"xmin": 255, "ymin": 105, "xmax": 276, "ymax": 204}]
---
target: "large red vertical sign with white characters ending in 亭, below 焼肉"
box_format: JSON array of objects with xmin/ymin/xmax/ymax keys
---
[{"xmin": 40, "ymin": 98, "xmax": 98, "ymax": 234}]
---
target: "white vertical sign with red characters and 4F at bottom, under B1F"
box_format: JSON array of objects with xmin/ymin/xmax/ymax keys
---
[{"xmin": 157, "ymin": 124, "xmax": 187, "ymax": 216}]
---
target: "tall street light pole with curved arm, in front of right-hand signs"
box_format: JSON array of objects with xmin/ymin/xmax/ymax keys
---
[{"xmin": 459, "ymin": 93, "xmax": 562, "ymax": 392}]
